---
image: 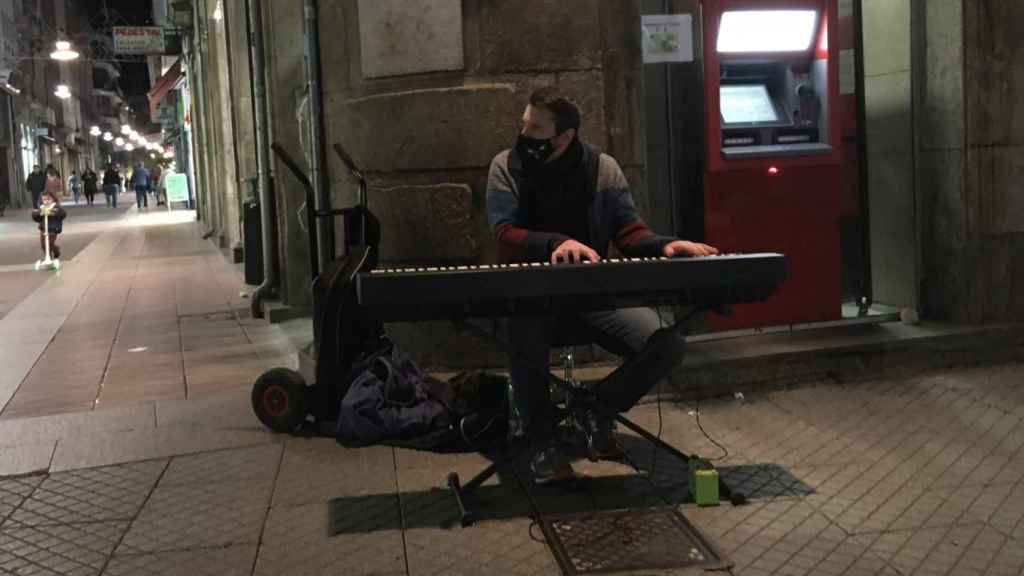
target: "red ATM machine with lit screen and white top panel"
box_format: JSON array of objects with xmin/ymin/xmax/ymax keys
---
[{"xmin": 702, "ymin": 0, "xmax": 842, "ymax": 329}]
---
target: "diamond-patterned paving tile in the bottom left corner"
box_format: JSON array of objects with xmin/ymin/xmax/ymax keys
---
[{"xmin": 0, "ymin": 522, "xmax": 128, "ymax": 576}]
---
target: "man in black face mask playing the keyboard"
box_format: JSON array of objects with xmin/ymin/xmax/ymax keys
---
[{"xmin": 486, "ymin": 87, "xmax": 718, "ymax": 484}]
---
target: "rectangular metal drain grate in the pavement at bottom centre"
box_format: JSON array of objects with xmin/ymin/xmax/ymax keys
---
[{"xmin": 541, "ymin": 507, "xmax": 726, "ymax": 575}]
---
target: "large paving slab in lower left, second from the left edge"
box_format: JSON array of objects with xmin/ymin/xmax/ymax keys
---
[{"xmin": 117, "ymin": 475, "xmax": 270, "ymax": 553}]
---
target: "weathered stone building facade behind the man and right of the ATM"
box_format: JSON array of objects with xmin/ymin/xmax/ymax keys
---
[{"xmin": 174, "ymin": 0, "xmax": 1024, "ymax": 362}]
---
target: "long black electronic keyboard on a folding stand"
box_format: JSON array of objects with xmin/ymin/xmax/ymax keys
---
[{"xmin": 355, "ymin": 253, "xmax": 785, "ymax": 322}]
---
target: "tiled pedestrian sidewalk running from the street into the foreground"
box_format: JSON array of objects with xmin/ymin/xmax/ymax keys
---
[{"xmin": 0, "ymin": 210, "xmax": 1024, "ymax": 576}]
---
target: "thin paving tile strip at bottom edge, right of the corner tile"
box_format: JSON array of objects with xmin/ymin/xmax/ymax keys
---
[{"xmin": 102, "ymin": 544, "xmax": 256, "ymax": 576}]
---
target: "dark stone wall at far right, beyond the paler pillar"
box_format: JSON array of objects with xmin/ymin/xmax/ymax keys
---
[{"xmin": 919, "ymin": 0, "xmax": 1024, "ymax": 323}]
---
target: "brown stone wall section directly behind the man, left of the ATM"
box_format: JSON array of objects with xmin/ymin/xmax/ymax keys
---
[{"xmin": 321, "ymin": 0, "xmax": 646, "ymax": 262}]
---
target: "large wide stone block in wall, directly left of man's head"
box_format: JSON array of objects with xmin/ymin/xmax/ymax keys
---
[{"xmin": 325, "ymin": 83, "xmax": 526, "ymax": 172}]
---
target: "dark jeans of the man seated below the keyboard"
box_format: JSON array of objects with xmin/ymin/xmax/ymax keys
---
[{"xmin": 508, "ymin": 307, "xmax": 660, "ymax": 445}]
